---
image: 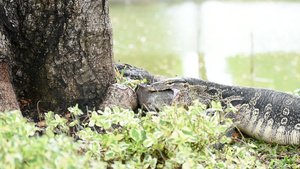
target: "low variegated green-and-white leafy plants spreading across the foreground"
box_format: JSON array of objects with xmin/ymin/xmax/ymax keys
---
[{"xmin": 0, "ymin": 102, "xmax": 299, "ymax": 168}]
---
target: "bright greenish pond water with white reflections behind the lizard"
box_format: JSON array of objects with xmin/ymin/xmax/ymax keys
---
[{"xmin": 110, "ymin": 1, "xmax": 300, "ymax": 91}]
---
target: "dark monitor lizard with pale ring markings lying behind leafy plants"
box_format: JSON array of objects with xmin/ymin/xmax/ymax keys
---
[{"xmin": 137, "ymin": 78, "xmax": 300, "ymax": 145}]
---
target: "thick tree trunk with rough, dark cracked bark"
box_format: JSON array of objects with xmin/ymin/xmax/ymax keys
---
[{"xmin": 0, "ymin": 0, "xmax": 114, "ymax": 111}]
